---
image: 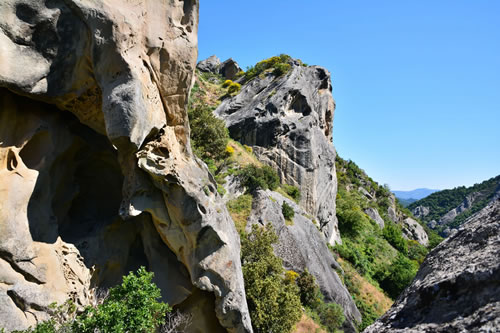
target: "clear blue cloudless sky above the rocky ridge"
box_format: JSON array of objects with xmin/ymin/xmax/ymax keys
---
[{"xmin": 199, "ymin": 0, "xmax": 500, "ymax": 190}]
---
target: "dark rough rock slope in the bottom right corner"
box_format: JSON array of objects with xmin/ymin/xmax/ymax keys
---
[{"xmin": 364, "ymin": 199, "xmax": 500, "ymax": 333}]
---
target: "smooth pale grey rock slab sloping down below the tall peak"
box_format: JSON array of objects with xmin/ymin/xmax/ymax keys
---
[{"xmin": 247, "ymin": 190, "xmax": 361, "ymax": 332}]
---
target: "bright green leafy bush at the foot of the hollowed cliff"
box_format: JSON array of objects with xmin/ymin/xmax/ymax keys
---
[{"xmin": 74, "ymin": 267, "xmax": 171, "ymax": 333}]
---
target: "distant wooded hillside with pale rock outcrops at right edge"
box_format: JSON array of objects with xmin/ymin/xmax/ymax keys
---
[{"xmin": 408, "ymin": 176, "xmax": 500, "ymax": 236}]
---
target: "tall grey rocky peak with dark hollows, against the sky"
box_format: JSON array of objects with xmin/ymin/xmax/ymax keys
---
[{"xmin": 215, "ymin": 63, "xmax": 341, "ymax": 244}]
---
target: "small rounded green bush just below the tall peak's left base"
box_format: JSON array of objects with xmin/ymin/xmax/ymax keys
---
[{"xmin": 238, "ymin": 164, "xmax": 280, "ymax": 193}]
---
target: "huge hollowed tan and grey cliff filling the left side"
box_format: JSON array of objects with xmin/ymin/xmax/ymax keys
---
[{"xmin": 0, "ymin": 0, "xmax": 252, "ymax": 332}]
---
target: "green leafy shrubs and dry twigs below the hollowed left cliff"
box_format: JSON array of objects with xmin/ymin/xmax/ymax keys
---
[{"xmin": 11, "ymin": 267, "xmax": 190, "ymax": 333}]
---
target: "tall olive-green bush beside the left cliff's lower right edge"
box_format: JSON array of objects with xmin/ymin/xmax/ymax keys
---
[{"xmin": 241, "ymin": 225, "xmax": 302, "ymax": 332}]
